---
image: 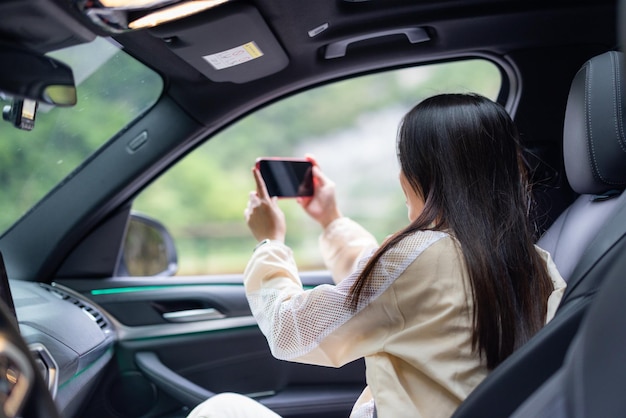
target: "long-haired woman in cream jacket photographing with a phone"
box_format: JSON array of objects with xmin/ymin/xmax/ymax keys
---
[{"xmin": 192, "ymin": 94, "xmax": 565, "ymax": 418}]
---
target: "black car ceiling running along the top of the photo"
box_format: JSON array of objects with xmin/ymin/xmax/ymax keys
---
[{"xmin": 0, "ymin": 0, "xmax": 616, "ymax": 126}]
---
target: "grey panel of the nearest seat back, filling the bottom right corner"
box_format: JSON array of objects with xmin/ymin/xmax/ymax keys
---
[{"xmin": 513, "ymin": 233, "xmax": 626, "ymax": 418}]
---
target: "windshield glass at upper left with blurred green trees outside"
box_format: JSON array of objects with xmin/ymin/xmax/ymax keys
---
[{"xmin": 0, "ymin": 38, "xmax": 163, "ymax": 233}]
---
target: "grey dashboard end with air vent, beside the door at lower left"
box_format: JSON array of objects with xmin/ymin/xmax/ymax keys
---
[{"xmin": 9, "ymin": 281, "xmax": 116, "ymax": 416}]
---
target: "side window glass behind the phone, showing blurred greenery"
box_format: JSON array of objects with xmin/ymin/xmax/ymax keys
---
[{"xmin": 133, "ymin": 59, "xmax": 502, "ymax": 275}]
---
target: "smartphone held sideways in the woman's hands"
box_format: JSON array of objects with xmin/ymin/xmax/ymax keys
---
[{"xmin": 256, "ymin": 157, "xmax": 313, "ymax": 197}]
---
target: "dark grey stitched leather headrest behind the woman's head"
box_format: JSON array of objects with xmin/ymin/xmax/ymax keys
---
[{"xmin": 563, "ymin": 51, "xmax": 626, "ymax": 194}]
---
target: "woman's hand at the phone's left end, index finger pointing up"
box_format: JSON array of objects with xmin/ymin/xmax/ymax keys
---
[{"xmin": 244, "ymin": 167, "xmax": 287, "ymax": 242}]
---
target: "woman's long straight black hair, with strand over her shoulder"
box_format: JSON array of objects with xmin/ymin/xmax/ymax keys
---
[{"xmin": 349, "ymin": 94, "xmax": 553, "ymax": 369}]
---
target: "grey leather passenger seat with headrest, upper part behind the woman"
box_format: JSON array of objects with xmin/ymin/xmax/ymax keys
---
[{"xmin": 538, "ymin": 51, "xmax": 626, "ymax": 281}]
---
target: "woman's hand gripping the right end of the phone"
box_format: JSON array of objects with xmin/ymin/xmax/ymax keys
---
[{"xmin": 297, "ymin": 163, "xmax": 342, "ymax": 228}]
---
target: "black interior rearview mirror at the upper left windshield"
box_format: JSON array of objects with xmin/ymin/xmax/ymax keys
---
[{"xmin": 0, "ymin": 44, "xmax": 77, "ymax": 106}]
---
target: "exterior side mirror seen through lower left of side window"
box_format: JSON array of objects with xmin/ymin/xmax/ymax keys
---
[{"xmin": 116, "ymin": 213, "xmax": 178, "ymax": 276}]
